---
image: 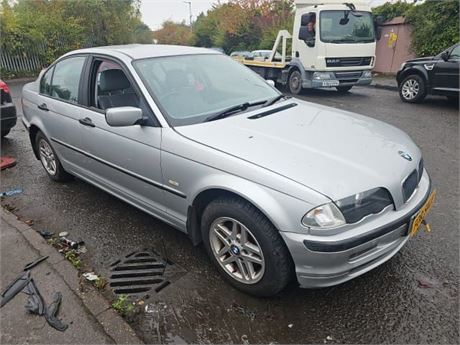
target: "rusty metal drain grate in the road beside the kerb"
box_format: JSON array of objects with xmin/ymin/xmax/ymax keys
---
[{"xmin": 109, "ymin": 250, "xmax": 173, "ymax": 295}]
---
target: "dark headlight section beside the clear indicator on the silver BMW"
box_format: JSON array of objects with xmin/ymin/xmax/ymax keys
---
[{"xmin": 335, "ymin": 188, "xmax": 393, "ymax": 223}]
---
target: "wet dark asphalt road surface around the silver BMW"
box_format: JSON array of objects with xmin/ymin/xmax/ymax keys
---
[{"xmin": 1, "ymin": 84, "xmax": 459, "ymax": 344}]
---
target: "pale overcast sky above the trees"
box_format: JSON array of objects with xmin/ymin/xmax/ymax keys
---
[{"xmin": 141, "ymin": 0, "xmax": 395, "ymax": 30}]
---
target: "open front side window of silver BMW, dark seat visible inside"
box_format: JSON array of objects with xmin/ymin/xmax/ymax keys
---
[{"xmin": 92, "ymin": 60, "xmax": 140, "ymax": 110}]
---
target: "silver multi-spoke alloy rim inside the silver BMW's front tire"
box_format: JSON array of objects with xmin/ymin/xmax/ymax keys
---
[{"xmin": 209, "ymin": 217, "xmax": 265, "ymax": 284}]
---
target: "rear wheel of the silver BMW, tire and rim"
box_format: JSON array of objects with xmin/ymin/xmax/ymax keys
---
[{"xmin": 35, "ymin": 132, "xmax": 73, "ymax": 182}]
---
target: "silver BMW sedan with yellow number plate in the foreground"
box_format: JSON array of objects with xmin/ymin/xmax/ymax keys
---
[{"xmin": 22, "ymin": 45, "xmax": 435, "ymax": 296}]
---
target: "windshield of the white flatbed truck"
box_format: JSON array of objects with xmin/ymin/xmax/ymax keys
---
[{"xmin": 320, "ymin": 10, "xmax": 375, "ymax": 43}]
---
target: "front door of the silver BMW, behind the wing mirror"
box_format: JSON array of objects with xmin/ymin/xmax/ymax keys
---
[{"xmin": 76, "ymin": 57, "xmax": 164, "ymax": 218}]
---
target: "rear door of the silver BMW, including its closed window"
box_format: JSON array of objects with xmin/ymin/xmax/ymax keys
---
[{"xmin": 37, "ymin": 55, "xmax": 87, "ymax": 172}]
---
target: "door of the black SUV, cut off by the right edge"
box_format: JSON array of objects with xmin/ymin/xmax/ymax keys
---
[{"xmin": 433, "ymin": 45, "xmax": 460, "ymax": 92}]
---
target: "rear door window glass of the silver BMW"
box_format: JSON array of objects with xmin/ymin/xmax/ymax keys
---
[{"xmin": 51, "ymin": 56, "xmax": 86, "ymax": 103}]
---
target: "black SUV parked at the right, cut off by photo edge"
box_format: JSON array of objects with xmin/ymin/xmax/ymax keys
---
[{"xmin": 396, "ymin": 44, "xmax": 460, "ymax": 103}]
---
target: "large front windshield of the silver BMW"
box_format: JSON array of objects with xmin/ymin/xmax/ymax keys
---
[{"xmin": 133, "ymin": 54, "xmax": 280, "ymax": 126}]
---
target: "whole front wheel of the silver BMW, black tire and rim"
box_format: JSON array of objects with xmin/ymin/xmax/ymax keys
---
[{"xmin": 201, "ymin": 197, "xmax": 294, "ymax": 297}]
